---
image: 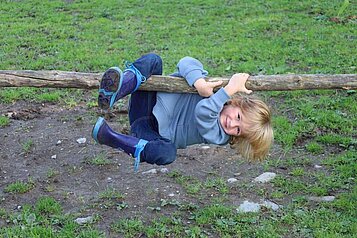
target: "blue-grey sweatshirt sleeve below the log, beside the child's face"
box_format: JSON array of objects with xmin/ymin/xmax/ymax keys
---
[{"xmin": 195, "ymin": 88, "xmax": 230, "ymax": 145}]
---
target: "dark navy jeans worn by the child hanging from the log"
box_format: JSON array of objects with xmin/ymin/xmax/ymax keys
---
[{"xmin": 129, "ymin": 53, "xmax": 177, "ymax": 165}]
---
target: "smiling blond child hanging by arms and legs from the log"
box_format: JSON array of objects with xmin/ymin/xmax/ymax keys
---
[{"xmin": 92, "ymin": 54, "xmax": 273, "ymax": 170}]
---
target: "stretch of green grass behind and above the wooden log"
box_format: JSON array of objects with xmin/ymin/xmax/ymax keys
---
[{"xmin": 0, "ymin": 0, "xmax": 356, "ymax": 75}]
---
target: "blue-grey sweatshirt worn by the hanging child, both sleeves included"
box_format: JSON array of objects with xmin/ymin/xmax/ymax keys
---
[{"xmin": 153, "ymin": 57, "xmax": 230, "ymax": 149}]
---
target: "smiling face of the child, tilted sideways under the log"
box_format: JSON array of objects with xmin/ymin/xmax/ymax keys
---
[{"xmin": 219, "ymin": 105, "xmax": 247, "ymax": 136}]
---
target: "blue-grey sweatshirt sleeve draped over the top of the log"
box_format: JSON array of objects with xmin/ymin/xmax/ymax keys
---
[{"xmin": 172, "ymin": 56, "xmax": 208, "ymax": 87}]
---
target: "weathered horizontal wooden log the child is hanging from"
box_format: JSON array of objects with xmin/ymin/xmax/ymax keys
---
[{"xmin": 0, "ymin": 70, "xmax": 357, "ymax": 93}]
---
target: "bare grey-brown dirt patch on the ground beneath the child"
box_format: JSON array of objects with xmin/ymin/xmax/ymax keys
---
[{"xmin": 0, "ymin": 92, "xmax": 287, "ymax": 235}]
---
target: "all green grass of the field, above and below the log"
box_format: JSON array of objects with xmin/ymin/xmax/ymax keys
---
[{"xmin": 0, "ymin": 0, "xmax": 357, "ymax": 237}]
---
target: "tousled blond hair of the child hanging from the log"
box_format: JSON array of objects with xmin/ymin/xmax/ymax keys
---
[{"xmin": 227, "ymin": 95, "xmax": 274, "ymax": 161}]
